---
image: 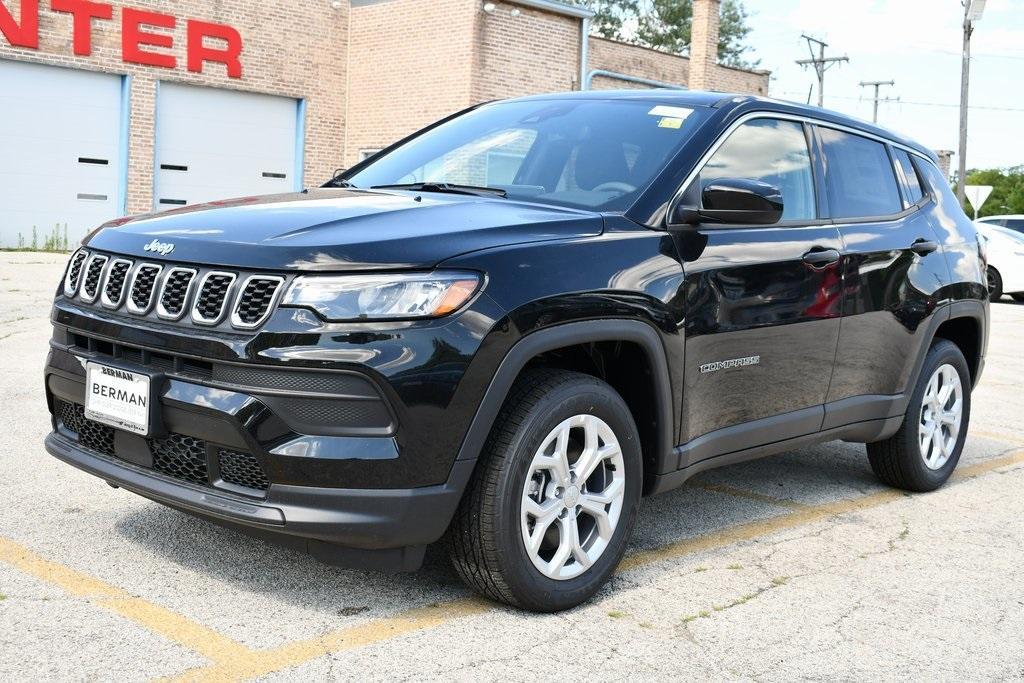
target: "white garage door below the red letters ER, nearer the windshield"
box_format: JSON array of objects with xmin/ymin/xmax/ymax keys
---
[{"xmin": 154, "ymin": 83, "xmax": 301, "ymax": 210}]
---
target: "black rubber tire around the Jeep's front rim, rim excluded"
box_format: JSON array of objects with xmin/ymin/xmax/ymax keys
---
[{"xmin": 495, "ymin": 380, "xmax": 643, "ymax": 611}]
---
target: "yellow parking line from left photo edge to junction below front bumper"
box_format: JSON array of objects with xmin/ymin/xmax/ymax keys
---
[{"xmin": 0, "ymin": 537, "xmax": 250, "ymax": 661}]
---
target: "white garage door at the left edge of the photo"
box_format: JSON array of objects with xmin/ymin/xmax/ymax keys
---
[{"xmin": 0, "ymin": 60, "xmax": 124, "ymax": 247}]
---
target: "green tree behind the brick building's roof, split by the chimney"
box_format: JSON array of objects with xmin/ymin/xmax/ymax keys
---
[{"xmin": 577, "ymin": 0, "xmax": 760, "ymax": 69}]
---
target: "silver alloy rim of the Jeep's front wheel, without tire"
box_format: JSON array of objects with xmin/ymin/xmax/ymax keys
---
[{"xmin": 520, "ymin": 415, "xmax": 626, "ymax": 581}]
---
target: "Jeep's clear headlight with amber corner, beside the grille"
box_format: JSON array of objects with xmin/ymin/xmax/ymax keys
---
[{"xmin": 283, "ymin": 271, "xmax": 480, "ymax": 322}]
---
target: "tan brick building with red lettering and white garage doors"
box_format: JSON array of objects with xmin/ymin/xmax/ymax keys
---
[{"xmin": 0, "ymin": 0, "xmax": 768, "ymax": 246}]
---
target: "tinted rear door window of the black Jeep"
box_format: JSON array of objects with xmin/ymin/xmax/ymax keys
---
[{"xmin": 818, "ymin": 127, "xmax": 903, "ymax": 218}]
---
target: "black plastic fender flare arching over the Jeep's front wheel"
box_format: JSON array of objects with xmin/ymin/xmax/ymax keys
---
[{"xmin": 456, "ymin": 319, "xmax": 675, "ymax": 476}]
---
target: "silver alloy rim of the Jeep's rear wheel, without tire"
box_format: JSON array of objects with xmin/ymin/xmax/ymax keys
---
[{"xmin": 918, "ymin": 364, "xmax": 964, "ymax": 470}]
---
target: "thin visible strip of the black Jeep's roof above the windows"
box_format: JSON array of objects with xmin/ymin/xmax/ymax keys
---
[{"xmin": 499, "ymin": 89, "xmax": 938, "ymax": 161}]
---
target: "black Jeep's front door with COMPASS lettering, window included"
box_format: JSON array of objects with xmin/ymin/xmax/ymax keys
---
[{"xmin": 676, "ymin": 115, "xmax": 842, "ymax": 467}]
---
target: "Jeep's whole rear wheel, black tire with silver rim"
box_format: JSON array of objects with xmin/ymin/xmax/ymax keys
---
[{"xmin": 867, "ymin": 339, "xmax": 971, "ymax": 492}]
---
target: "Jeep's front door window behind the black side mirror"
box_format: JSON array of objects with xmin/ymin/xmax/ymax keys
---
[{"xmin": 700, "ymin": 119, "xmax": 818, "ymax": 220}]
